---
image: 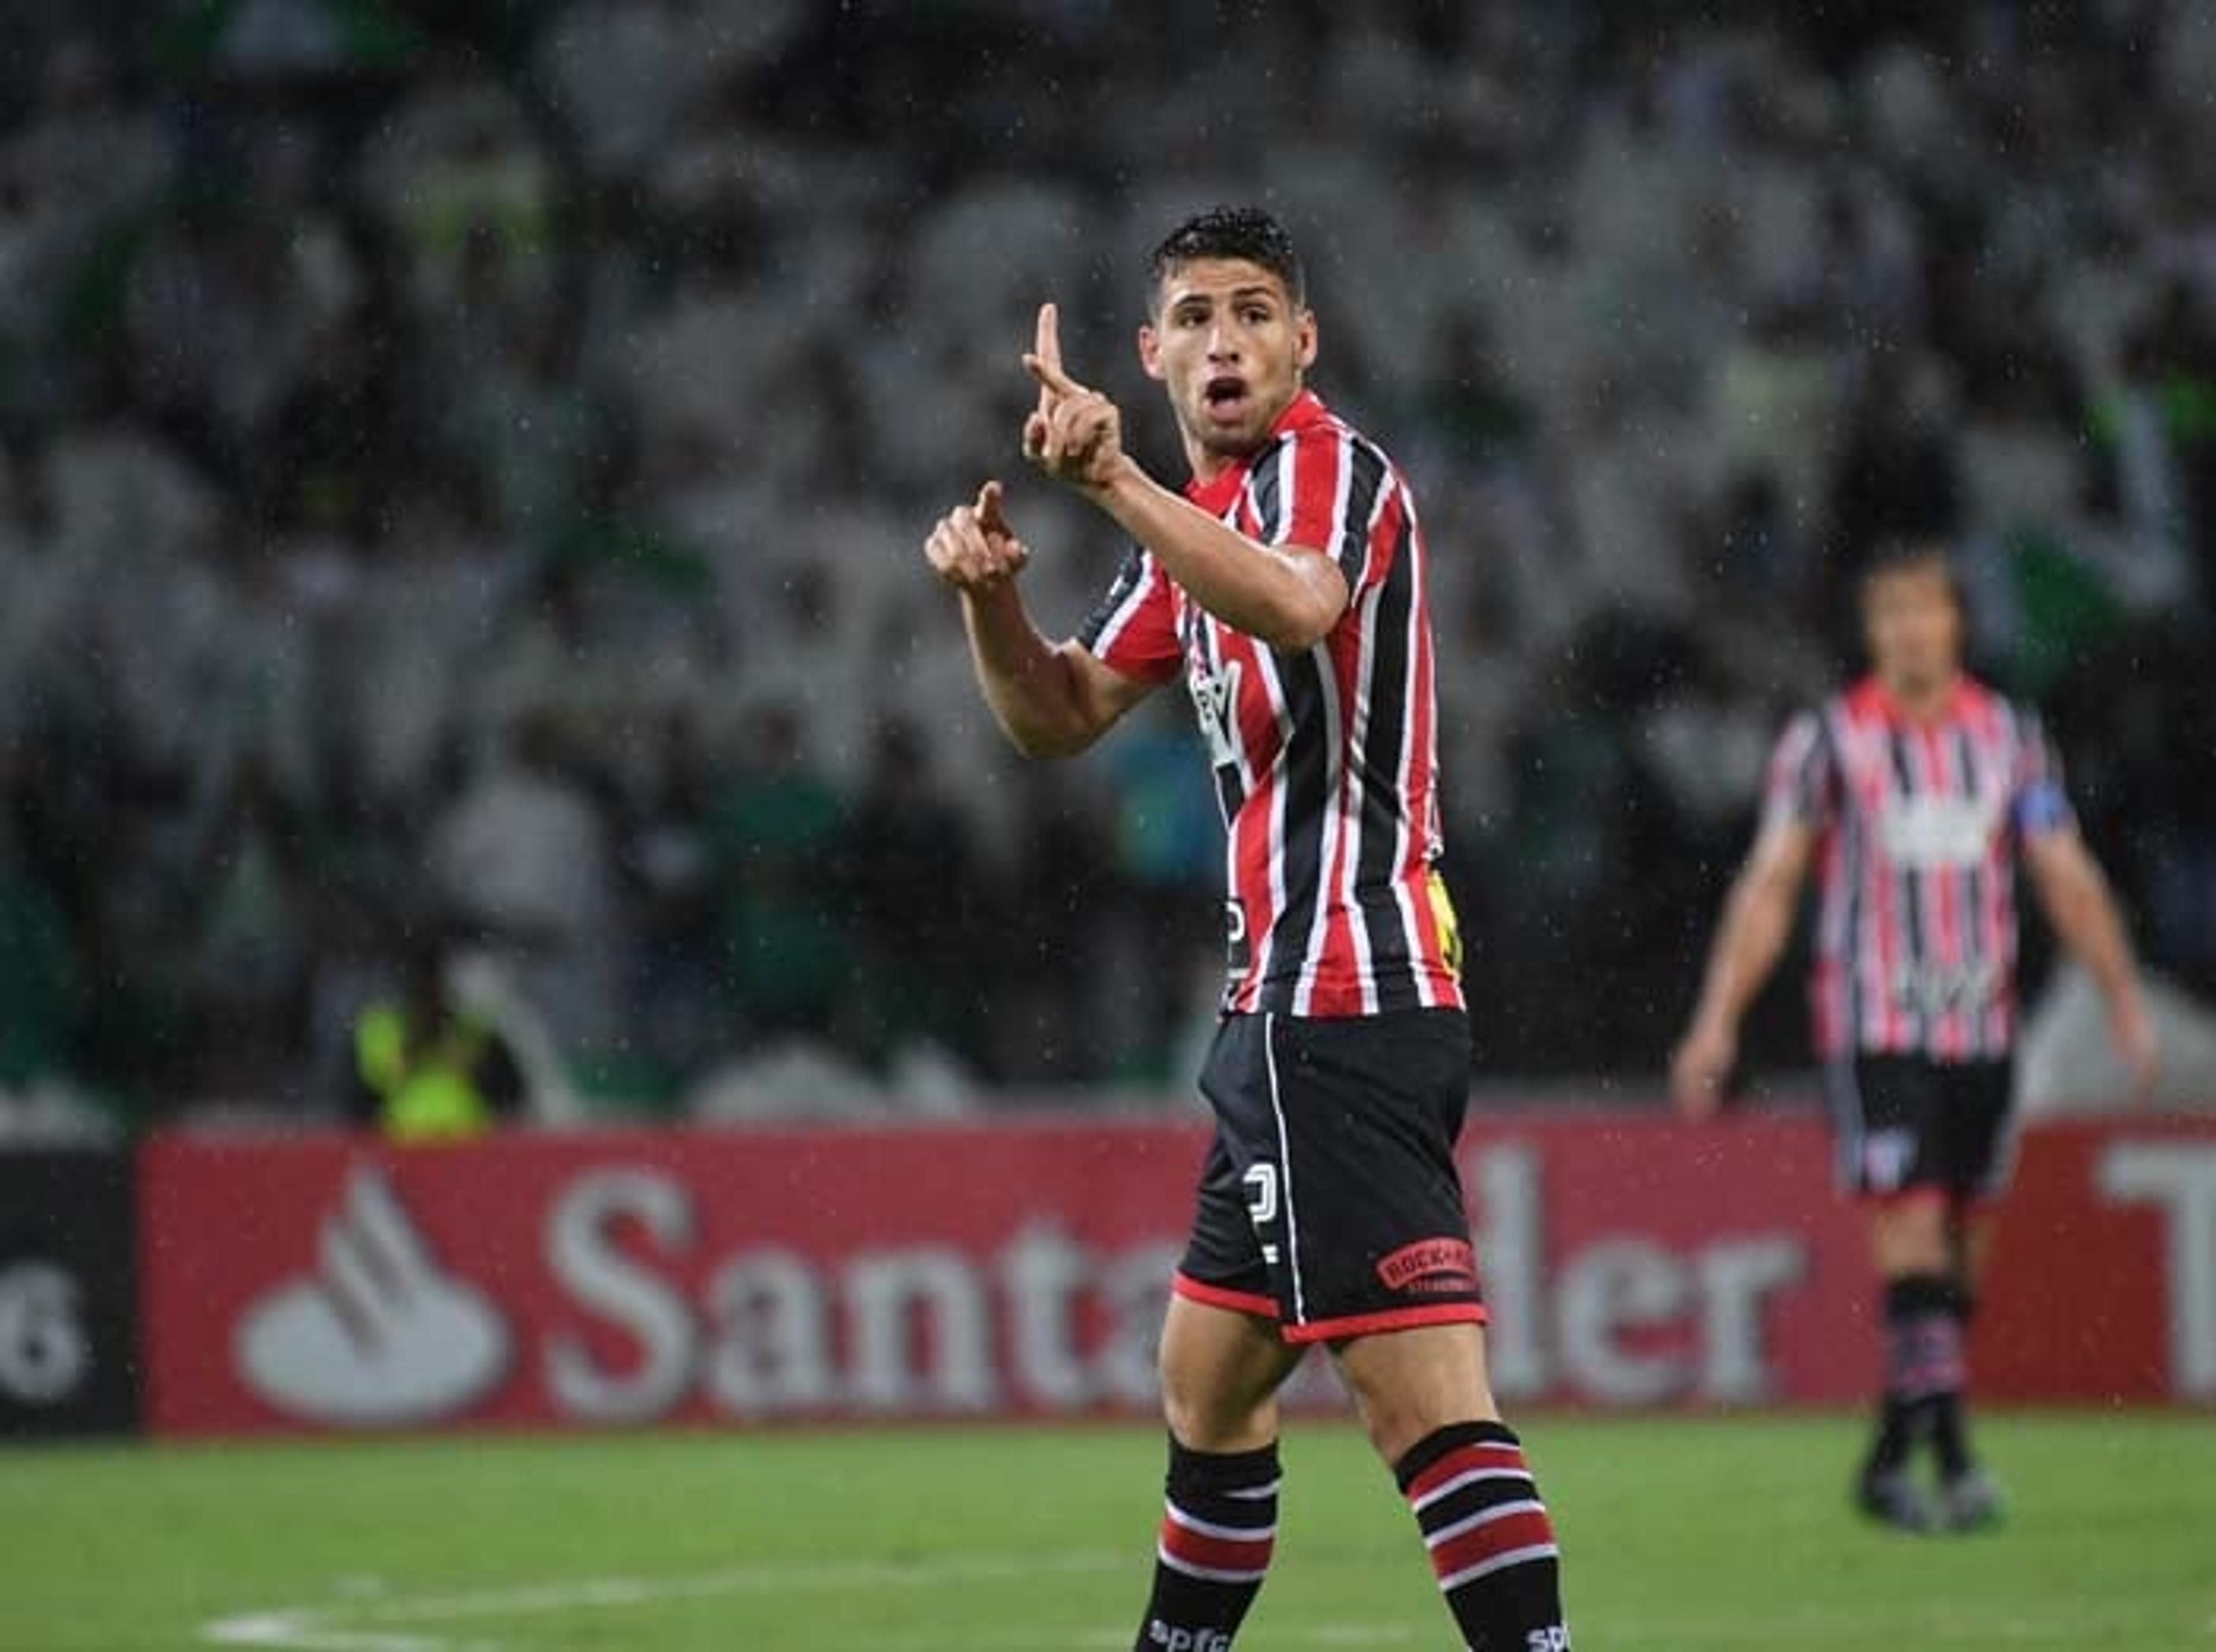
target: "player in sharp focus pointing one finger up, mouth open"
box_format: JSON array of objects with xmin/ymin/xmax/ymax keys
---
[{"xmin": 926, "ymin": 208, "xmax": 1569, "ymax": 1652}]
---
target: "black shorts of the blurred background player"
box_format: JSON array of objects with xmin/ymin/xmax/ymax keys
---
[{"xmin": 1826, "ymin": 1054, "xmax": 2015, "ymax": 1203}]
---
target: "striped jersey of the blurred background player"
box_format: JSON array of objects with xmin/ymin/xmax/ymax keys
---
[{"xmin": 1766, "ymin": 677, "xmax": 2072, "ymax": 1061}]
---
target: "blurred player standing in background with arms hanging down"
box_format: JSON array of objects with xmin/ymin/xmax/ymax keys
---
[{"xmin": 1671, "ymin": 540, "xmax": 2156, "ymax": 1530}]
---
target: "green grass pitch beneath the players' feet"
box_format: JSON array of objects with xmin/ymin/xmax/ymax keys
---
[{"xmin": 0, "ymin": 1415, "xmax": 2216, "ymax": 1652}]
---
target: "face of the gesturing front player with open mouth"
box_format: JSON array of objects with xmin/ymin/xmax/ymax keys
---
[{"xmin": 1139, "ymin": 259, "xmax": 1316, "ymax": 470}]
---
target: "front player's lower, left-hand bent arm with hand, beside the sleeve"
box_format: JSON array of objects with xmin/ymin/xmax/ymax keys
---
[{"xmin": 924, "ymin": 483, "xmax": 1155, "ymax": 758}]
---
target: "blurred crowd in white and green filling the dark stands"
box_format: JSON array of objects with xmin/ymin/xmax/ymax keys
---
[{"xmin": 0, "ymin": 0, "xmax": 2216, "ymax": 1118}]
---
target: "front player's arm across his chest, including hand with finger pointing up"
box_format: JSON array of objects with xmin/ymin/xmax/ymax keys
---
[{"xmin": 1024, "ymin": 304, "xmax": 1350, "ymax": 653}]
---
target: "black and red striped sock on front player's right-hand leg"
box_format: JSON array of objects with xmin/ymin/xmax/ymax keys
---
[{"xmin": 1394, "ymin": 1422, "xmax": 1569, "ymax": 1652}]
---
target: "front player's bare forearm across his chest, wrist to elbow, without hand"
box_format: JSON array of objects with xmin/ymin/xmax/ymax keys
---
[{"xmin": 1086, "ymin": 458, "xmax": 1347, "ymax": 653}]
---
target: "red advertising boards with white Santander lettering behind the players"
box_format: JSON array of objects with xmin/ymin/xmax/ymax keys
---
[{"xmin": 140, "ymin": 1114, "xmax": 2216, "ymax": 1433}]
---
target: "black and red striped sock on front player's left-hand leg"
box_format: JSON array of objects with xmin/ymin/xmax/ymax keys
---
[{"xmin": 1137, "ymin": 1437, "xmax": 1279, "ymax": 1652}]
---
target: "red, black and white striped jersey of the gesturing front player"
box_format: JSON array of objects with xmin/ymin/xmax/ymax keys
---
[{"xmin": 1079, "ymin": 392, "xmax": 1462, "ymax": 1017}]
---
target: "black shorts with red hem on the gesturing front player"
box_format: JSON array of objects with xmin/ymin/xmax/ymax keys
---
[{"xmin": 1174, "ymin": 1010, "xmax": 1485, "ymax": 1342}]
